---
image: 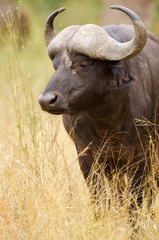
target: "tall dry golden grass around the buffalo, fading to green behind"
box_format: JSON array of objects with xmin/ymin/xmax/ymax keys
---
[{"xmin": 0, "ymin": 0, "xmax": 159, "ymax": 240}]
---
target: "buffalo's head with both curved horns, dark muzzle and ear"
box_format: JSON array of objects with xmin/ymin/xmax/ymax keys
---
[{"xmin": 39, "ymin": 6, "xmax": 147, "ymax": 114}]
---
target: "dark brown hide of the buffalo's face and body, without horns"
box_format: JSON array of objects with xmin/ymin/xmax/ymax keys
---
[{"xmin": 39, "ymin": 14, "xmax": 159, "ymax": 204}]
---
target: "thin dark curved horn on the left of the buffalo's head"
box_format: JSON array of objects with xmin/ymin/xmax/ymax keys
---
[{"xmin": 44, "ymin": 8, "xmax": 66, "ymax": 46}]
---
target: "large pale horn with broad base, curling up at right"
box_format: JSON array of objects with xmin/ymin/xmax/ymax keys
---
[{"xmin": 68, "ymin": 6, "xmax": 147, "ymax": 61}]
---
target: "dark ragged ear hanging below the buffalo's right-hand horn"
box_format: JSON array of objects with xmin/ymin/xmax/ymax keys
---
[{"xmin": 107, "ymin": 65, "xmax": 136, "ymax": 89}]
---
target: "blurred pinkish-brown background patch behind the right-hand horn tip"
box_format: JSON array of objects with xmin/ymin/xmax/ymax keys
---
[{"xmin": 100, "ymin": 0, "xmax": 156, "ymax": 29}]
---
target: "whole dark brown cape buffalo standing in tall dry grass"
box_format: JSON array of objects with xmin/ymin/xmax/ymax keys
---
[{"xmin": 38, "ymin": 6, "xmax": 159, "ymax": 202}]
